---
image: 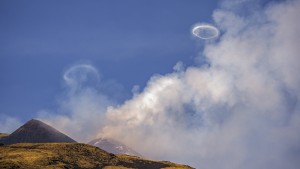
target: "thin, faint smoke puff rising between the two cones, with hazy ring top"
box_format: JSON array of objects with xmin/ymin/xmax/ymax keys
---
[{"xmin": 38, "ymin": 64, "xmax": 114, "ymax": 142}]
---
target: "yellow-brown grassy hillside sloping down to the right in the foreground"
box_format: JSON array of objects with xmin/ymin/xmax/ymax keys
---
[{"xmin": 0, "ymin": 143, "xmax": 191, "ymax": 169}]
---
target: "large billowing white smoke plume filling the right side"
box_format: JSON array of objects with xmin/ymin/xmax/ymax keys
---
[{"xmin": 99, "ymin": 1, "xmax": 300, "ymax": 169}]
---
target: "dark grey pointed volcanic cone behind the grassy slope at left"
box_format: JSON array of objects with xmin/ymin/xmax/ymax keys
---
[{"xmin": 1, "ymin": 119, "xmax": 76, "ymax": 145}]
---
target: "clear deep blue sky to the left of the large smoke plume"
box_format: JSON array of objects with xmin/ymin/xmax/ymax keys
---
[{"xmin": 0, "ymin": 0, "xmax": 217, "ymax": 121}]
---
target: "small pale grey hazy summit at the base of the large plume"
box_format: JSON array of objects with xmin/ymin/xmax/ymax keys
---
[{"xmin": 88, "ymin": 138, "xmax": 142, "ymax": 157}]
